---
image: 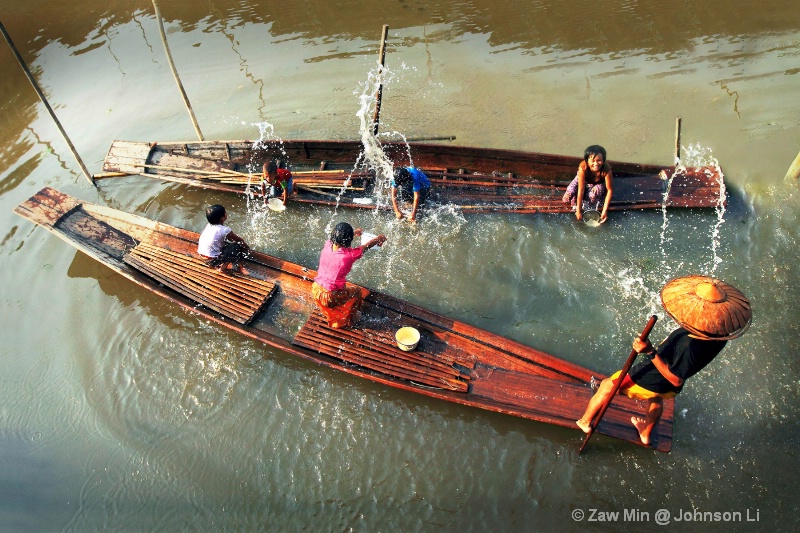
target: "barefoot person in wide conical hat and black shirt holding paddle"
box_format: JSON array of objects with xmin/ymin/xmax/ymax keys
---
[{"xmin": 577, "ymin": 276, "xmax": 752, "ymax": 445}]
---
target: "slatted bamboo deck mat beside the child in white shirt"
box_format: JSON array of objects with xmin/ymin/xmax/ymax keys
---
[{"xmin": 123, "ymin": 243, "xmax": 275, "ymax": 324}]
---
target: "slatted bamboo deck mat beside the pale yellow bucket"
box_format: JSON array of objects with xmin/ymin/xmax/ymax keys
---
[{"xmin": 292, "ymin": 308, "xmax": 470, "ymax": 392}]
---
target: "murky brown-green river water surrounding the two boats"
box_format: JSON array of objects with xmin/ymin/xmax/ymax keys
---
[{"xmin": 0, "ymin": 0, "xmax": 800, "ymax": 531}]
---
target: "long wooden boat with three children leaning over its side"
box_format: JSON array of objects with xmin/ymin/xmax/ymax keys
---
[{"xmin": 97, "ymin": 140, "xmax": 724, "ymax": 213}]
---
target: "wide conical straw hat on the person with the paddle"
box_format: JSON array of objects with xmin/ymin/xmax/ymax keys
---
[{"xmin": 661, "ymin": 276, "xmax": 753, "ymax": 340}]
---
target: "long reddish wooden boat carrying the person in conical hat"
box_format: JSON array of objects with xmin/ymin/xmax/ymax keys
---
[{"xmin": 15, "ymin": 188, "xmax": 674, "ymax": 452}]
